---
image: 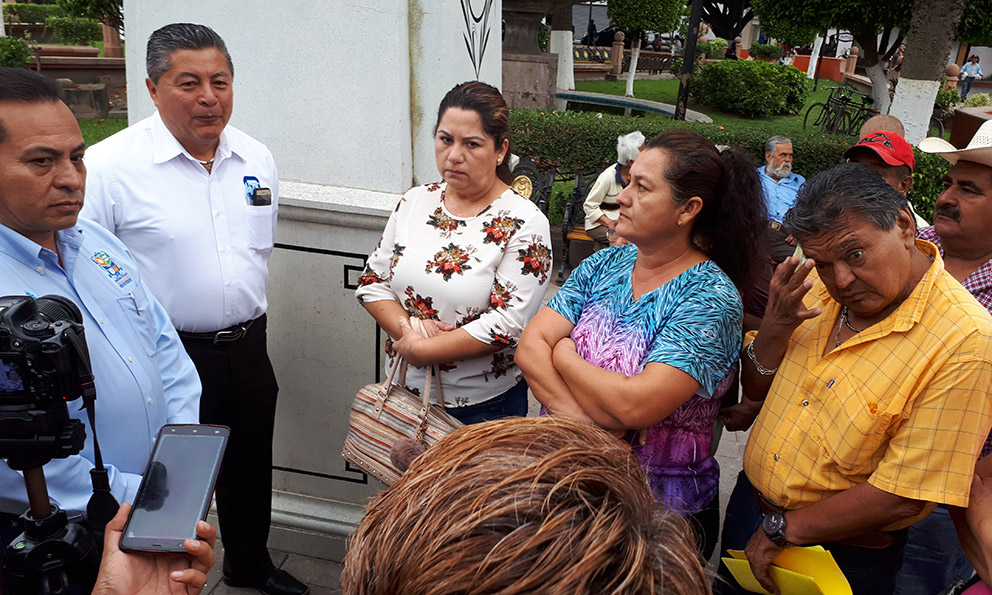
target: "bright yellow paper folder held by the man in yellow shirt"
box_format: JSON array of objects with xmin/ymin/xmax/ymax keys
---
[{"xmin": 723, "ymin": 546, "xmax": 852, "ymax": 595}]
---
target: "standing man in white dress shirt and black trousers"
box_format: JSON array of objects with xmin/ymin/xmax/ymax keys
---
[{"xmin": 82, "ymin": 24, "xmax": 307, "ymax": 595}]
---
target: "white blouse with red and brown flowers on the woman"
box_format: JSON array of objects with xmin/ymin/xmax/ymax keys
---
[{"xmin": 356, "ymin": 183, "xmax": 551, "ymax": 407}]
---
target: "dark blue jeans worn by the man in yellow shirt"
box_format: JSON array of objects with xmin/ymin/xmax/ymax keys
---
[{"xmin": 713, "ymin": 471, "xmax": 907, "ymax": 595}]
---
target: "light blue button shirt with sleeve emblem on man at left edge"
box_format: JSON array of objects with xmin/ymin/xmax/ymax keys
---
[{"xmin": 0, "ymin": 219, "xmax": 200, "ymax": 514}]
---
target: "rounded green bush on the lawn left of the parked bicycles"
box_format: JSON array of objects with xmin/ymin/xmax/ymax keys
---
[{"xmin": 690, "ymin": 60, "xmax": 809, "ymax": 118}]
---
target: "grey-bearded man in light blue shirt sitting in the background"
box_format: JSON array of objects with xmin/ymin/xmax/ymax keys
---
[{"xmin": 758, "ymin": 136, "xmax": 806, "ymax": 263}]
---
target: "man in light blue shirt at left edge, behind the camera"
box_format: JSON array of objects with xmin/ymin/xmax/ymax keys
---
[{"xmin": 0, "ymin": 68, "xmax": 200, "ymax": 520}]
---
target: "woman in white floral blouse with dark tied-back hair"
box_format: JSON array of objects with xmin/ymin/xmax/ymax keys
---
[{"xmin": 356, "ymin": 81, "xmax": 551, "ymax": 423}]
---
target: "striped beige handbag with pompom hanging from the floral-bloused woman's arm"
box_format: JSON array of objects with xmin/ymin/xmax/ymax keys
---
[{"xmin": 341, "ymin": 357, "xmax": 463, "ymax": 485}]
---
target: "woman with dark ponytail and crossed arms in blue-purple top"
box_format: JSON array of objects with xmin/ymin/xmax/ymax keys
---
[{"xmin": 516, "ymin": 131, "xmax": 766, "ymax": 557}]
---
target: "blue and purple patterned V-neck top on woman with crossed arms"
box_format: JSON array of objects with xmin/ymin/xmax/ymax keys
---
[{"xmin": 548, "ymin": 245, "xmax": 743, "ymax": 513}]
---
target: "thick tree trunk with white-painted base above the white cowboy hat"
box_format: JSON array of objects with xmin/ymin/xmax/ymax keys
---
[{"xmin": 892, "ymin": 0, "xmax": 965, "ymax": 145}]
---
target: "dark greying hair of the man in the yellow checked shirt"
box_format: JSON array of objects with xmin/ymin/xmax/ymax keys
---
[{"xmin": 782, "ymin": 162, "xmax": 909, "ymax": 242}]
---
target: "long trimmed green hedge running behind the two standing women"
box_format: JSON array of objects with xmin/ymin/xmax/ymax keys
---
[{"xmin": 510, "ymin": 108, "xmax": 950, "ymax": 221}]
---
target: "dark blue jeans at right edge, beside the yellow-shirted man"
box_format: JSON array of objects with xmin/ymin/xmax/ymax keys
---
[{"xmin": 894, "ymin": 506, "xmax": 974, "ymax": 595}]
